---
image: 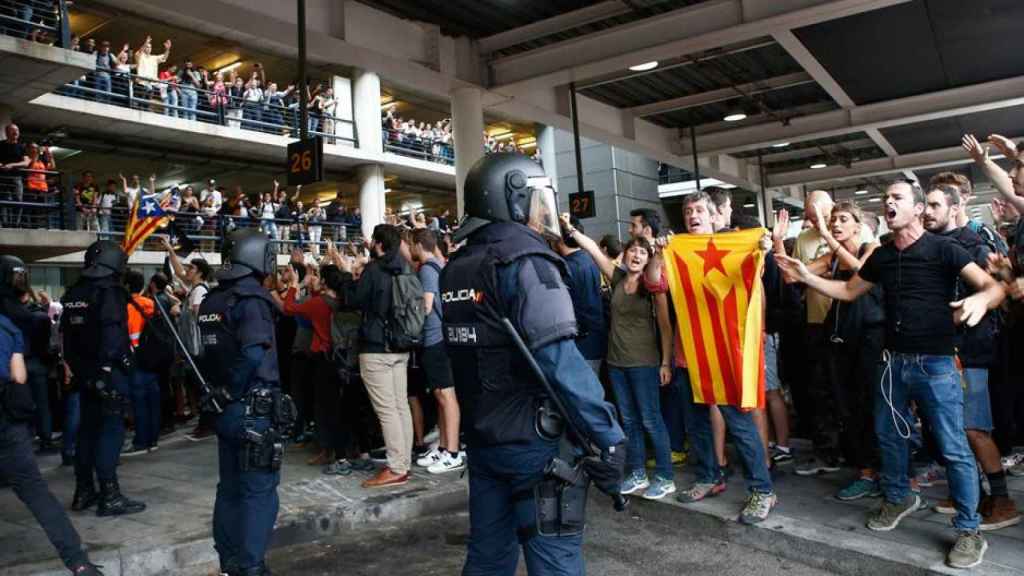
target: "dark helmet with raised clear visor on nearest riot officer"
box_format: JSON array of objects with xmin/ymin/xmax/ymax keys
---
[{"xmin": 453, "ymin": 153, "xmax": 560, "ymax": 242}]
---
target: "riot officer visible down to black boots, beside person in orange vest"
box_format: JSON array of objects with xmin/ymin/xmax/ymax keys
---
[{"xmin": 60, "ymin": 240, "xmax": 145, "ymax": 517}]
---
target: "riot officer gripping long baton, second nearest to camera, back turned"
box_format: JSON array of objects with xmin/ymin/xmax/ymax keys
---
[{"xmin": 198, "ymin": 230, "xmax": 294, "ymax": 576}]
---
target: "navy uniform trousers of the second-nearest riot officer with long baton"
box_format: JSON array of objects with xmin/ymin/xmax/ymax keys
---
[{"xmin": 213, "ymin": 403, "xmax": 281, "ymax": 570}]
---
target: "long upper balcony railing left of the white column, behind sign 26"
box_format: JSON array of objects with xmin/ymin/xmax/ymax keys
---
[{"xmin": 57, "ymin": 70, "xmax": 356, "ymax": 147}]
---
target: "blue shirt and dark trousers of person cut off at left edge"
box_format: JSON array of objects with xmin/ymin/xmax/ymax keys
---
[{"xmin": 0, "ymin": 316, "xmax": 99, "ymax": 575}]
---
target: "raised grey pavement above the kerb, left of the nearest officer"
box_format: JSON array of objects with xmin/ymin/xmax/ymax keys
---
[{"xmin": 0, "ymin": 430, "xmax": 466, "ymax": 576}]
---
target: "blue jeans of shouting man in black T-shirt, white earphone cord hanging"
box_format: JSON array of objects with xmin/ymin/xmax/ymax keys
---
[{"xmin": 874, "ymin": 354, "xmax": 980, "ymax": 531}]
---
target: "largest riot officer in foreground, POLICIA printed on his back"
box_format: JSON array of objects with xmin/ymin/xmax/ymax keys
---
[{"xmin": 441, "ymin": 154, "xmax": 626, "ymax": 576}]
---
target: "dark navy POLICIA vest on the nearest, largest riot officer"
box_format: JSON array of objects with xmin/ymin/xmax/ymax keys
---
[{"xmin": 440, "ymin": 224, "xmax": 565, "ymax": 448}]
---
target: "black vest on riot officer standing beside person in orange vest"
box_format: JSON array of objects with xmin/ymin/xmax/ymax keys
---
[{"xmin": 60, "ymin": 280, "xmax": 102, "ymax": 379}]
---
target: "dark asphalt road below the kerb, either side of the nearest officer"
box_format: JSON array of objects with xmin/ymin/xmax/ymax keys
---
[{"xmin": 270, "ymin": 507, "xmax": 834, "ymax": 576}]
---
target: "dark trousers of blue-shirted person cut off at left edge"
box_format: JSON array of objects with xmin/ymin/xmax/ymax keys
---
[{"xmin": 0, "ymin": 414, "xmax": 88, "ymax": 569}]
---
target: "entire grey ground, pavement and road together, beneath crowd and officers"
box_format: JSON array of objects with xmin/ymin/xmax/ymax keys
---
[{"xmin": 0, "ymin": 430, "xmax": 1024, "ymax": 576}]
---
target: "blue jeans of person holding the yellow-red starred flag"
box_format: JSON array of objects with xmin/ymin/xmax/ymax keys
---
[{"xmin": 690, "ymin": 397, "xmax": 772, "ymax": 494}]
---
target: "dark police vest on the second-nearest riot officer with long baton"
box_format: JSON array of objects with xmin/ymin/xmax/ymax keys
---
[{"xmin": 197, "ymin": 285, "xmax": 273, "ymax": 398}]
